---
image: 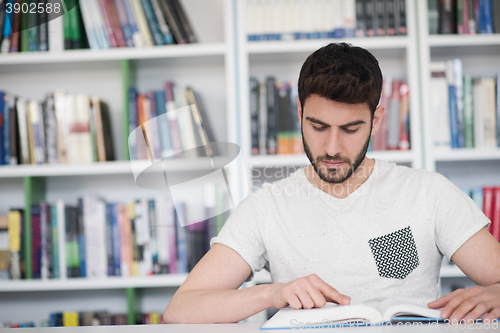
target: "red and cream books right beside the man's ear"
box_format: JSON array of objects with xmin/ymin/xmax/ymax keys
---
[{"xmin": 368, "ymin": 77, "xmax": 410, "ymax": 151}]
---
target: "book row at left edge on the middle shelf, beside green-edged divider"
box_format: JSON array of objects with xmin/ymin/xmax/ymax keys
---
[{"xmin": 0, "ymin": 90, "xmax": 115, "ymax": 165}]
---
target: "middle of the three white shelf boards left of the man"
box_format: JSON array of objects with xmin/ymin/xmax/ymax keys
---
[{"xmin": 0, "ymin": 157, "xmax": 222, "ymax": 178}]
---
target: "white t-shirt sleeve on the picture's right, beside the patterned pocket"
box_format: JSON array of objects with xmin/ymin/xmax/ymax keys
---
[{"xmin": 429, "ymin": 174, "xmax": 490, "ymax": 259}]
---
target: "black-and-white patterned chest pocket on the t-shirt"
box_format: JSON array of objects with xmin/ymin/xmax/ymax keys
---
[{"xmin": 368, "ymin": 226, "xmax": 419, "ymax": 279}]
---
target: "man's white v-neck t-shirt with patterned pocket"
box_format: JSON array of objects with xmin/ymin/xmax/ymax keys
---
[{"xmin": 211, "ymin": 160, "xmax": 489, "ymax": 304}]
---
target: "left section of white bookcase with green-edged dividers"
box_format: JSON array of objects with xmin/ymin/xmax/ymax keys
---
[{"xmin": 0, "ymin": 0, "xmax": 238, "ymax": 325}]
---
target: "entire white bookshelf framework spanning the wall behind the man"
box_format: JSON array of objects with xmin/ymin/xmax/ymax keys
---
[{"xmin": 0, "ymin": 0, "xmax": 500, "ymax": 323}]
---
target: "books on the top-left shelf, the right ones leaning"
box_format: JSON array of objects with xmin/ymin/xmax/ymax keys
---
[{"xmin": 0, "ymin": 0, "xmax": 197, "ymax": 53}]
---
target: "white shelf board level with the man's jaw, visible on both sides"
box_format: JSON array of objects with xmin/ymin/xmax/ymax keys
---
[{"xmin": 250, "ymin": 150, "xmax": 413, "ymax": 168}]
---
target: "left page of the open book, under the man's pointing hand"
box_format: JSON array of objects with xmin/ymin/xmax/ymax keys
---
[{"xmin": 261, "ymin": 303, "xmax": 382, "ymax": 329}]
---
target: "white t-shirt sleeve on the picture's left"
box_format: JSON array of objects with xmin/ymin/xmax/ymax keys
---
[{"xmin": 210, "ymin": 189, "xmax": 267, "ymax": 281}]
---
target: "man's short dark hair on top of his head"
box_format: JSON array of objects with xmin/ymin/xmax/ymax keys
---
[{"xmin": 298, "ymin": 43, "xmax": 383, "ymax": 116}]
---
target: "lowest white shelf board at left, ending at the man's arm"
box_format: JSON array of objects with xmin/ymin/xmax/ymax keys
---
[{"xmin": 0, "ymin": 274, "xmax": 187, "ymax": 292}]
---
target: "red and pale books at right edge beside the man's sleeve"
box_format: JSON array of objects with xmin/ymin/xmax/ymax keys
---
[{"xmin": 463, "ymin": 186, "xmax": 500, "ymax": 241}]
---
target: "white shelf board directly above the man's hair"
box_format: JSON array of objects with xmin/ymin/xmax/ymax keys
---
[{"xmin": 246, "ymin": 36, "xmax": 409, "ymax": 54}]
